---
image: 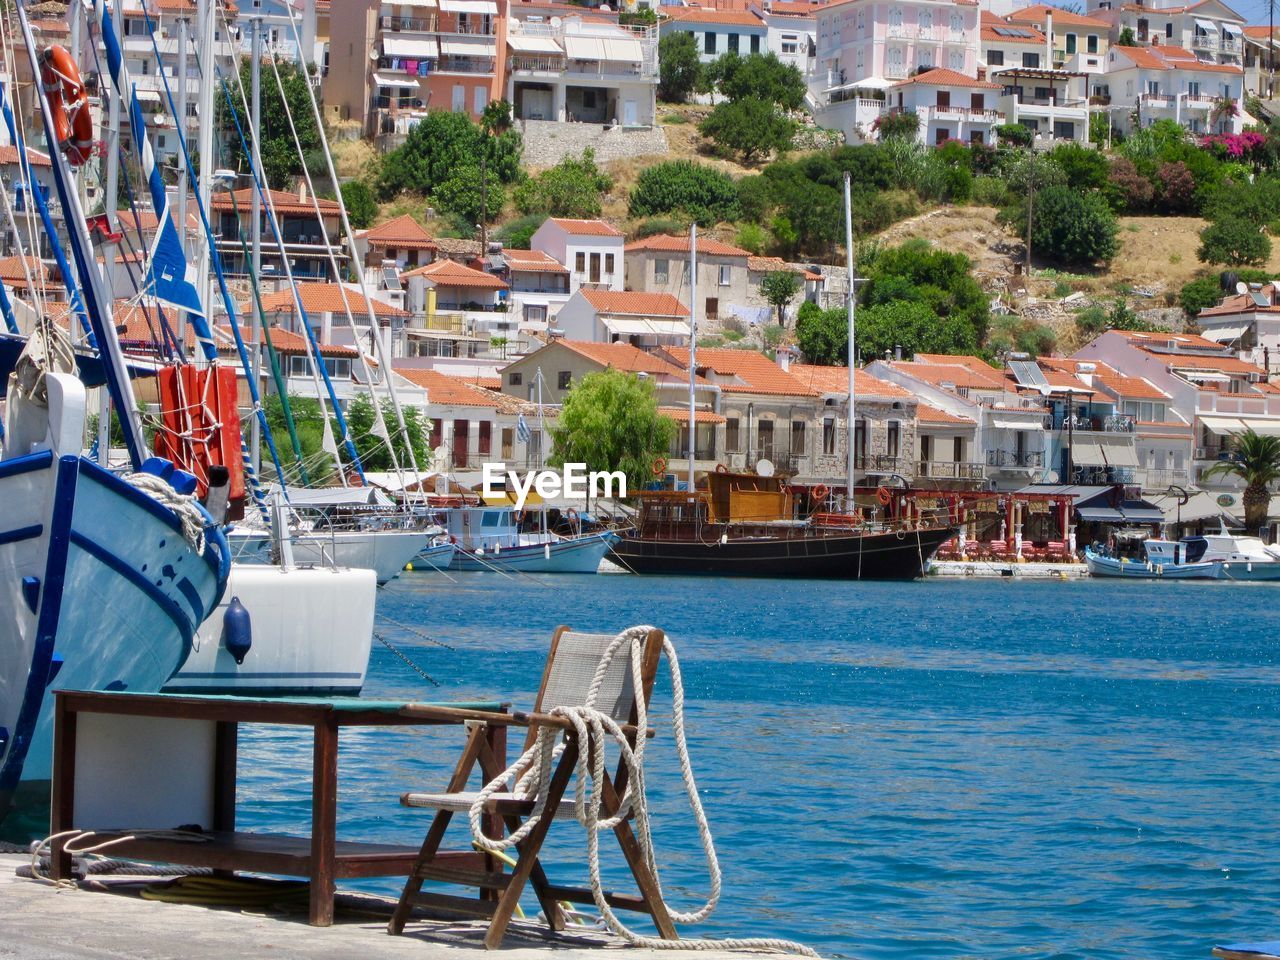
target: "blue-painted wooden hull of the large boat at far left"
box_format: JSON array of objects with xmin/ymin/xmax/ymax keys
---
[{"xmin": 0, "ymin": 452, "xmax": 229, "ymax": 832}]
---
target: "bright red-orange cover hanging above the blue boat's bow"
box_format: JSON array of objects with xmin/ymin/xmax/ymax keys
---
[{"xmin": 156, "ymin": 364, "xmax": 244, "ymax": 500}]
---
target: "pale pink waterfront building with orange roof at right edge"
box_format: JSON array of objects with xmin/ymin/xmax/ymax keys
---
[{"xmin": 1073, "ymin": 330, "xmax": 1280, "ymax": 490}]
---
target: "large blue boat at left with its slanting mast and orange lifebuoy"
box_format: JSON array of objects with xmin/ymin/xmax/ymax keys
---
[{"xmin": 0, "ymin": 0, "xmax": 230, "ymax": 833}]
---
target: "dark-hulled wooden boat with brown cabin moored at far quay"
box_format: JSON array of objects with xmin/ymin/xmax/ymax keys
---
[{"xmin": 609, "ymin": 472, "xmax": 956, "ymax": 580}]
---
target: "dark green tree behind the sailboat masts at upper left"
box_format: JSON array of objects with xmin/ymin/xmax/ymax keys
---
[{"xmin": 214, "ymin": 58, "xmax": 321, "ymax": 189}]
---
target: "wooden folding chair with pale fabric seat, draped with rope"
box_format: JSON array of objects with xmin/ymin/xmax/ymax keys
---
[{"xmin": 388, "ymin": 626, "xmax": 677, "ymax": 950}]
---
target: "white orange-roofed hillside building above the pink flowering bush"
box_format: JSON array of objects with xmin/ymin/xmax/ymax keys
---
[{"xmin": 1105, "ymin": 44, "xmax": 1244, "ymax": 133}]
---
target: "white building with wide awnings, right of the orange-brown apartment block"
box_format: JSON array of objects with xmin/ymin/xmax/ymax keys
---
[{"xmin": 504, "ymin": 15, "xmax": 658, "ymax": 127}]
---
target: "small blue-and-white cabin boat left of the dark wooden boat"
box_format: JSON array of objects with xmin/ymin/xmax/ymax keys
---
[{"xmin": 444, "ymin": 506, "xmax": 618, "ymax": 573}]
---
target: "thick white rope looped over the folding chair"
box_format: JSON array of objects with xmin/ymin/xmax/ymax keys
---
[{"xmin": 470, "ymin": 626, "xmax": 818, "ymax": 956}]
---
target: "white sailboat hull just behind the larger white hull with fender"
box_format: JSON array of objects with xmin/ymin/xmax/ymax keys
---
[{"xmin": 228, "ymin": 530, "xmax": 433, "ymax": 586}]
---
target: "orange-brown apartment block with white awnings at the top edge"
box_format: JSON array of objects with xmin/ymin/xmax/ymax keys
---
[{"xmin": 324, "ymin": 0, "xmax": 507, "ymax": 147}]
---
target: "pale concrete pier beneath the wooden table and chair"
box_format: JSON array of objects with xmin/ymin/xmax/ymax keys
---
[{"xmin": 0, "ymin": 855, "xmax": 808, "ymax": 960}]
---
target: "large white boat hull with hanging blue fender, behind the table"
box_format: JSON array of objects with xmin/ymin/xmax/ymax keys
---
[{"xmin": 164, "ymin": 563, "xmax": 378, "ymax": 696}]
